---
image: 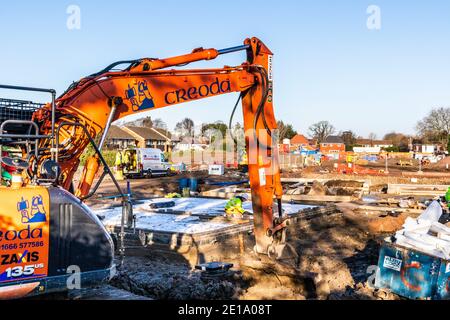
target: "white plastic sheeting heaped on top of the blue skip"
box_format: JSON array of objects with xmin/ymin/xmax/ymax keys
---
[{"xmin": 395, "ymin": 201, "xmax": 450, "ymax": 260}]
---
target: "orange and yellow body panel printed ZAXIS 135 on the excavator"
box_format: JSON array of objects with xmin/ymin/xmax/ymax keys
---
[{"xmin": 0, "ymin": 186, "xmax": 50, "ymax": 296}]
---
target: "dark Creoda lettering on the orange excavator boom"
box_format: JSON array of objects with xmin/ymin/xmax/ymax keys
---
[{"xmin": 165, "ymin": 78, "xmax": 231, "ymax": 105}]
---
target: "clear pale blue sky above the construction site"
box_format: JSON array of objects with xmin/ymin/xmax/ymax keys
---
[{"xmin": 0, "ymin": 0, "xmax": 450, "ymax": 136}]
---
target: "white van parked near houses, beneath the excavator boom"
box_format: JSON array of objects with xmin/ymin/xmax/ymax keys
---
[{"xmin": 122, "ymin": 148, "xmax": 172, "ymax": 178}]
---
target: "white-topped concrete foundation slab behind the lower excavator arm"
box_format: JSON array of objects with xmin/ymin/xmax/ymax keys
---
[{"xmin": 95, "ymin": 198, "xmax": 336, "ymax": 252}]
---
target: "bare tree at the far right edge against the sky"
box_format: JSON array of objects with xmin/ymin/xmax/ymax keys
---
[{"xmin": 417, "ymin": 108, "xmax": 450, "ymax": 145}]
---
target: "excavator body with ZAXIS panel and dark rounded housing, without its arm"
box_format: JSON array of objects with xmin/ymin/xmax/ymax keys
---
[{"xmin": 0, "ymin": 86, "xmax": 114, "ymax": 299}]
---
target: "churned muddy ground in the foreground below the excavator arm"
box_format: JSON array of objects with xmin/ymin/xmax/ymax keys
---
[{"xmin": 112, "ymin": 208, "xmax": 400, "ymax": 300}]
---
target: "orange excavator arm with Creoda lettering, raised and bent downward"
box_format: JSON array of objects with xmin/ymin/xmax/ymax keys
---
[{"xmin": 34, "ymin": 38, "xmax": 285, "ymax": 253}]
